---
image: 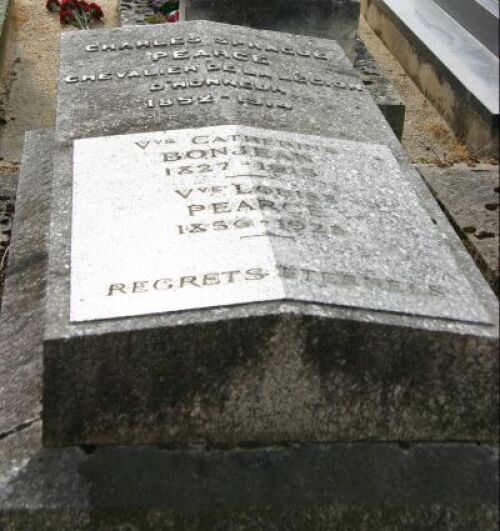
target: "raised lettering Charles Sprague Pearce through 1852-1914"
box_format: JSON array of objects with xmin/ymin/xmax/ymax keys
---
[{"xmin": 63, "ymin": 34, "xmax": 364, "ymax": 116}]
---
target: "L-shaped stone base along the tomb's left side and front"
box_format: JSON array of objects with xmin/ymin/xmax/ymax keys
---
[{"xmin": 0, "ymin": 131, "xmax": 498, "ymax": 531}]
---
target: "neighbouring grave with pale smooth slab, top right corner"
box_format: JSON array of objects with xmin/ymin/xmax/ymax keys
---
[{"xmin": 362, "ymin": 0, "xmax": 499, "ymax": 157}]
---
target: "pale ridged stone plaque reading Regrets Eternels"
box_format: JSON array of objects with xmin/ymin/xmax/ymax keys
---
[{"xmin": 71, "ymin": 126, "xmax": 488, "ymax": 322}]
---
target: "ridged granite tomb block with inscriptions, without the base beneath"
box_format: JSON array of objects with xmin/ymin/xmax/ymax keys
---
[{"xmin": 43, "ymin": 22, "xmax": 498, "ymax": 445}]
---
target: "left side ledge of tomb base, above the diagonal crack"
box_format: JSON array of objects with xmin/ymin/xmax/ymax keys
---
[{"xmin": 0, "ymin": 131, "xmax": 54, "ymax": 444}]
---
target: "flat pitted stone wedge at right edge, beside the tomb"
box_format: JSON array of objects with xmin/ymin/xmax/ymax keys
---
[{"xmin": 419, "ymin": 165, "xmax": 500, "ymax": 295}]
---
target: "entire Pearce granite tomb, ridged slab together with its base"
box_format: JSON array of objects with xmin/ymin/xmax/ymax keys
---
[{"xmin": 0, "ymin": 18, "xmax": 498, "ymax": 531}]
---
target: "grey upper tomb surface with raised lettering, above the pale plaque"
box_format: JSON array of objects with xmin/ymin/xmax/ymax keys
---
[{"xmin": 56, "ymin": 21, "xmax": 372, "ymax": 143}]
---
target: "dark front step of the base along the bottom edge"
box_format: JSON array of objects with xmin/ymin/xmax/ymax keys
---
[{"xmin": 0, "ymin": 434, "xmax": 498, "ymax": 531}]
